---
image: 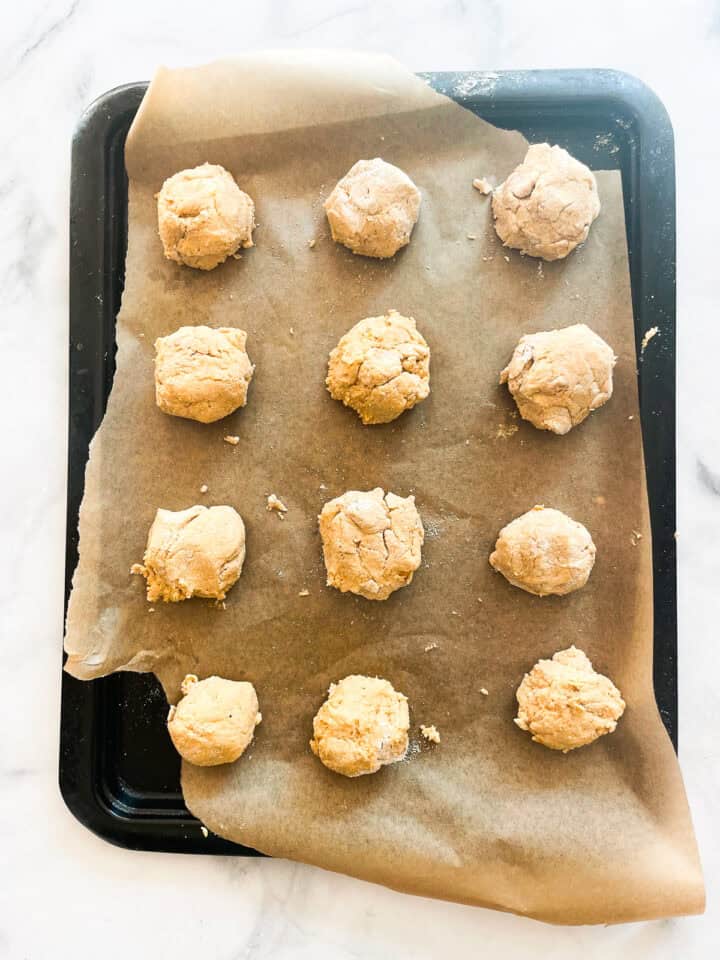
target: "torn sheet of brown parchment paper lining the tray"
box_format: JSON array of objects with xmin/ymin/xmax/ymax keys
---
[{"xmin": 66, "ymin": 53, "xmax": 703, "ymax": 923}]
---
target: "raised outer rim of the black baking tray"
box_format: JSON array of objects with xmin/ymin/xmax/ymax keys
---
[{"xmin": 58, "ymin": 69, "xmax": 677, "ymax": 856}]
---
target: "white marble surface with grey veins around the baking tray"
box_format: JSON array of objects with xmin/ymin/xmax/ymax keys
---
[{"xmin": 0, "ymin": 0, "xmax": 720, "ymax": 960}]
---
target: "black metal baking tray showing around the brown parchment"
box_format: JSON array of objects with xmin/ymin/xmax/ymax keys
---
[{"xmin": 60, "ymin": 70, "xmax": 677, "ymax": 855}]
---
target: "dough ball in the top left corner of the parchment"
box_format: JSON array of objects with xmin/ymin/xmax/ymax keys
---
[{"xmin": 157, "ymin": 163, "xmax": 255, "ymax": 270}]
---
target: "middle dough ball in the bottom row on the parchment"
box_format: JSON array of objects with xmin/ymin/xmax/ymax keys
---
[{"xmin": 310, "ymin": 675, "xmax": 410, "ymax": 777}]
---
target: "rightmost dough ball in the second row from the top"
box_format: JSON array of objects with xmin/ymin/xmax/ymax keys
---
[{"xmin": 500, "ymin": 323, "xmax": 615, "ymax": 434}]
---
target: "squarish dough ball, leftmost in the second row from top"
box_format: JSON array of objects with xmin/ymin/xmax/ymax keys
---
[{"xmin": 155, "ymin": 327, "xmax": 255, "ymax": 423}]
